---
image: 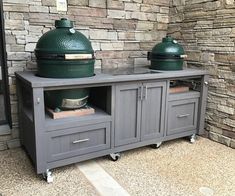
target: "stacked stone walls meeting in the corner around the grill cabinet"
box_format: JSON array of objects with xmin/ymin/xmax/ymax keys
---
[{"xmin": 1, "ymin": 0, "xmax": 235, "ymax": 149}]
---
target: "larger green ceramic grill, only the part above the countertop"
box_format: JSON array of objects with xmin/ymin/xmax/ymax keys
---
[{"xmin": 35, "ymin": 18, "xmax": 95, "ymax": 78}]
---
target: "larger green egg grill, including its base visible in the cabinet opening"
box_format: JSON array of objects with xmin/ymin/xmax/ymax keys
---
[{"xmin": 35, "ymin": 18, "xmax": 95, "ymax": 109}]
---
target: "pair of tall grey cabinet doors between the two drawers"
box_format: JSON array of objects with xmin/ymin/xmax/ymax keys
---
[{"xmin": 115, "ymin": 82, "xmax": 166, "ymax": 146}]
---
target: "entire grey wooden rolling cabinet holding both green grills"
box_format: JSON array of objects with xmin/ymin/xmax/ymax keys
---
[{"xmin": 16, "ymin": 70, "xmax": 208, "ymax": 181}]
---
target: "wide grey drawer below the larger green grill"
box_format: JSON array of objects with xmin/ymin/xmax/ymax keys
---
[{"xmin": 47, "ymin": 122, "xmax": 110, "ymax": 162}]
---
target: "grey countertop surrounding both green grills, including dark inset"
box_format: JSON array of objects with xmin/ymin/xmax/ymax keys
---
[{"xmin": 16, "ymin": 67, "xmax": 208, "ymax": 88}]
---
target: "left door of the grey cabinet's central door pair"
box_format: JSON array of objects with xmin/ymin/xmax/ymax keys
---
[{"xmin": 115, "ymin": 84, "xmax": 141, "ymax": 146}]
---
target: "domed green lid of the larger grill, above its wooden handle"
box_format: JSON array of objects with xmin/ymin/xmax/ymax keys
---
[{"xmin": 35, "ymin": 18, "xmax": 94, "ymax": 58}]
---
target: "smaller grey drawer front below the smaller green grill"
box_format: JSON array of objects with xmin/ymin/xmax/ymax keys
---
[{"xmin": 167, "ymin": 98, "xmax": 198, "ymax": 135}]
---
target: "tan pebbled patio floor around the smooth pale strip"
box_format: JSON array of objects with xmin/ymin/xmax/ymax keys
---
[{"xmin": 0, "ymin": 137, "xmax": 235, "ymax": 196}]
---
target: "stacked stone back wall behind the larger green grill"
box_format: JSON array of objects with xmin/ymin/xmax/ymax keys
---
[{"xmin": 0, "ymin": 0, "xmax": 169, "ymax": 150}]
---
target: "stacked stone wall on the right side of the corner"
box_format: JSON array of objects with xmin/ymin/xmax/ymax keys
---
[{"xmin": 168, "ymin": 0, "xmax": 235, "ymax": 148}]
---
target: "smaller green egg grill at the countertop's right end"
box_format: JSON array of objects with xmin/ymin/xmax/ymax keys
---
[{"xmin": 148, "ymin": 36, "xmax": 186, "ymax": 70}]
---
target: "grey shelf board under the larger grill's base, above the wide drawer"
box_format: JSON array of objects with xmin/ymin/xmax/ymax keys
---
[{"xmin": 45, "ymin": 106, "xmax": 112, "ymax": 131}]
